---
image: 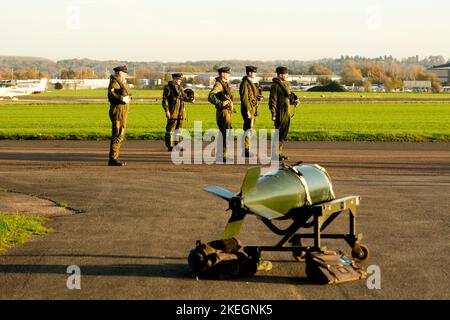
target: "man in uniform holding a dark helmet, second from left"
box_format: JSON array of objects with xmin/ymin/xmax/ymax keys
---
[{"xmin": 162, "ymin": 73, "xmax": 189, "ymax": 151}]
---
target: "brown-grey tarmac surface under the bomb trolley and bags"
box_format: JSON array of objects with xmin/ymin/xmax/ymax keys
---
[{"xmin": 0, "ymin": 140, "xmax": 450, "ymax": 300}]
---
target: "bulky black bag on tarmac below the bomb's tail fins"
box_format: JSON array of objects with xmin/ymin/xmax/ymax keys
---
[{"xmin": 188, "ymin": 238, "xmax": 259, "ymax": 280}]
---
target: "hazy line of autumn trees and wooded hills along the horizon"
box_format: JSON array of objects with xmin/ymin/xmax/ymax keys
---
[{"xmin": 0, "ymin": 55, "xmax": 449, "ymax": 92}]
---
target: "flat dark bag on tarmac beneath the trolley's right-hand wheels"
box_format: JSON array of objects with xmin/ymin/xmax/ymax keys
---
[{"xmin": 305, "ymin": 251, "xmax": 367, "ymax": 284}]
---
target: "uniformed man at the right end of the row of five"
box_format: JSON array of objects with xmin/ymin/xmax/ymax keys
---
[{"xmin": 269, "ymin": 67, "xmax": 291, "ymax": 160}]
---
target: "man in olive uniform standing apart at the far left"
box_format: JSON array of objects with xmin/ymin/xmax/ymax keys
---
[{"xmin": 108, "ymin": 66, "xmax": 131, "ymax": 166}]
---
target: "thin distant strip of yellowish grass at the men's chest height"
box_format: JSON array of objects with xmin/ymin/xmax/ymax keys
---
[{"xmin": 39, "ymin": 89, "xmax": 450, "ymax": 99}]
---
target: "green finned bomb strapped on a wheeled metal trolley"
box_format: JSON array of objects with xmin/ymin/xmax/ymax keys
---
[{"xmin": 204, "ymin": 162, "xmax": 369, "ymax": 262}]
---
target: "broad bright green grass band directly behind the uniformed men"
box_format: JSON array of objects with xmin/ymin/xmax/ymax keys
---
[{"xmin": 0, "ymin": 101, "xmax": 450, "ymax": 142}]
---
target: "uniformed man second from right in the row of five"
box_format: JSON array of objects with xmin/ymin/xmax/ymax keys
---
[{"xmin": 239, "ymin": 66, "xmax": 262, "ymax": 157}]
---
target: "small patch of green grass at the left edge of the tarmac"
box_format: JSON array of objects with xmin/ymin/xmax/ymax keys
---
[{"xmin": 0, "ymin": 213, "xmax": 50, "ymax": 253}]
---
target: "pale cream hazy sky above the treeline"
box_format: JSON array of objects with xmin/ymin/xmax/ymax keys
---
[{"xmin": 0, "ymin": 0, "xmax": 450, "ymax": 62}]
